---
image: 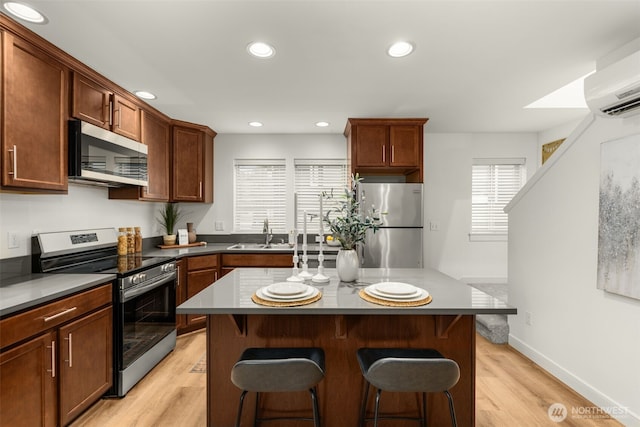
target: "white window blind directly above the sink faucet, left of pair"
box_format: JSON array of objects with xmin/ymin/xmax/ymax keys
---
[{"xmin": 233, "ymin": 159, "xmax": 286, "ymax": 233}]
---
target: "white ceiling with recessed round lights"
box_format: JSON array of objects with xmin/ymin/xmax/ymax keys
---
[{"xmin": 7, "ymin": 0, "xmax": 640, "ymax": 134}]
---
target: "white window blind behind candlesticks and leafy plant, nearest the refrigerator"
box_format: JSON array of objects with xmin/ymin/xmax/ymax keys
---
[{"xmin": 294, "ymin": 159, "xmax": 347, "ymax": 234}]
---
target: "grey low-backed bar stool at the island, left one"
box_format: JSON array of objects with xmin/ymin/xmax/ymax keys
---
[{"xmin": 231, "ymin": 347, "xmax": 324, "ymax": 427}]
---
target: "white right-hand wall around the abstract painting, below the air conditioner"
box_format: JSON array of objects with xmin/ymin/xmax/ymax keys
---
[{"xmin": 508, "ymin": 112, "xmax": 640, "ymax": 426}]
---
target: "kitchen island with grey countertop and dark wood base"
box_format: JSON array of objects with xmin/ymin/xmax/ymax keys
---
[{"xmin": 177, "ymin": 268, "xmax": 516, "ymax": 427}]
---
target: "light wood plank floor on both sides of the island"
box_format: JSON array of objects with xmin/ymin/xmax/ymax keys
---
[{"xmin": 72, "ymin": 331, "xmax": 621, "ymax": 427}]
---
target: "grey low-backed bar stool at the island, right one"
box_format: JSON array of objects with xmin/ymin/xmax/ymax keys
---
[{"xmin": 357, "ymin": 348, "xmax": 460, "ymax": 427}]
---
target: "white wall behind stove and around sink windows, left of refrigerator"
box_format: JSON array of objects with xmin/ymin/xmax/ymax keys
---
[{"xmin": 0, "ymin": 134, "xmax": 347, "ymax": 259}]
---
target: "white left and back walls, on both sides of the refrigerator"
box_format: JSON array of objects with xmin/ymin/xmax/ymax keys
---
[{"xmin": 0, "ymin": 133, "xmax": 537, "ymax": 288}]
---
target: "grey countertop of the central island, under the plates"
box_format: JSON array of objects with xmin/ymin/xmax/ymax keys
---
[{"xmin": 177, "ymin": 268, "xmax": 517, "ymax": 315}]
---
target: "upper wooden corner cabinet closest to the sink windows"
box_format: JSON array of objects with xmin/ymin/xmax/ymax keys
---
[{"xmin": 171, "ymin": 120, "xmax": 216, "ymax": 203}]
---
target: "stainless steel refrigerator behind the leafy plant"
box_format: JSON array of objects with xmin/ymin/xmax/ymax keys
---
[{"xmin": 358, "ymin": 183, "xmax": 423, "ymax": 268}]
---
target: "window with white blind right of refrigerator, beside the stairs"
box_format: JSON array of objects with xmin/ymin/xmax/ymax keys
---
[{"xmin": 471, "ymin": 159, "xmax": 526, "ymax": 239}]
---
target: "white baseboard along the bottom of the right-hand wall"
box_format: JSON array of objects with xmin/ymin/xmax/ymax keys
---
[{"xmin": 509, "ymin": 334, "xmax": 640, "ymax": 427}]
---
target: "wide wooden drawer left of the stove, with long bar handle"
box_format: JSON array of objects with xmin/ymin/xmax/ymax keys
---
[{"xmin": 0, "ymin": 283, "xmax": 113, "ymax": 348}]
